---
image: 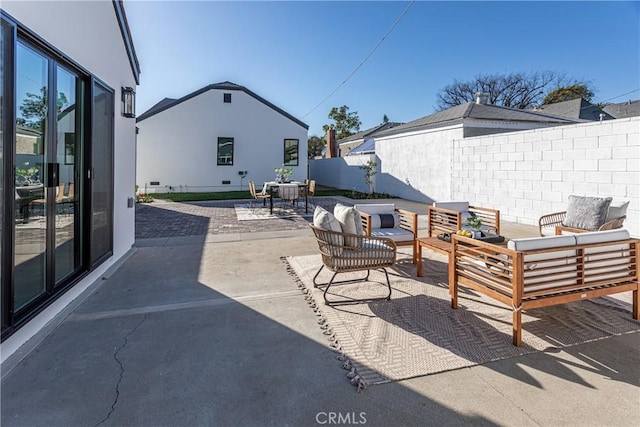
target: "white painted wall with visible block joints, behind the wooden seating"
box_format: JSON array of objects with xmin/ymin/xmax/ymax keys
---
[{"xmin": 451, "ymin": 117, "xmax": 640, "ymax": 236}]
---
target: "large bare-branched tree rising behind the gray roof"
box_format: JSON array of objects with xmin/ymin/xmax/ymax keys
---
[{"xmin": 436, "ymin": 71, "xmax": 587, "ymax": 111}]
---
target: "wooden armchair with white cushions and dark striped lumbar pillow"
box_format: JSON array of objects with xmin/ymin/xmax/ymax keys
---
[{"xmin": 354, "ymin": 203, "xmax": 418, "ymax": 264}]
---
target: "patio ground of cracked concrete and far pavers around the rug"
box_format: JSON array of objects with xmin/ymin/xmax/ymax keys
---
[{"xmin": 0, "ymin": 199, "xmax": 640, "ymax": 426}]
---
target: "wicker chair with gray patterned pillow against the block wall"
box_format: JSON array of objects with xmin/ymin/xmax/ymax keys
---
[{"xmin": 538, "ymin": 195, "xmax": 629, "ymax": 236}]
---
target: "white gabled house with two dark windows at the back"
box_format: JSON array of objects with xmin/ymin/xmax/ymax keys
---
[{"xmin": 136, "ymin": 82, "xmax": 309, "ymax": 193}]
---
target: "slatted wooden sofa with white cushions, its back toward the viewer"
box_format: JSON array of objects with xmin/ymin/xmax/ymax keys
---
[{"xmin": 449, "ymin": 229, "xmax": 640, "ymax": 346}]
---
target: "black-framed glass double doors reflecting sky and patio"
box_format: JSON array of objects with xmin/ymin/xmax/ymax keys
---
[{"xmin": 13, "ymin": 42, "xmax": 84, "ymax": 312}]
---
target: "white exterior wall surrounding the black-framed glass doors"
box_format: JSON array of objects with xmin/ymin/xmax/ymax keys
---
[{"xmin": 1, "ymin": 1, "xmax": 136, "ymax": 361}]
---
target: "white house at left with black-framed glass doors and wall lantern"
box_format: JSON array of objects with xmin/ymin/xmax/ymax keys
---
[{"xmin": 0, "ymin": 0, "xmax": 140, "ymax": 364}]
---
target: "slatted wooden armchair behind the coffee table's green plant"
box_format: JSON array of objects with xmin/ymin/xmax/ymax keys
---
[{"xmin": 427, "ymin": 202, "xmax": 500, "ymax": 237}]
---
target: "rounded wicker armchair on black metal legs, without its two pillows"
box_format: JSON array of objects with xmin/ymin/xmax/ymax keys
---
[{"xmin": 310, "ymin": 225, "xmax": 396, "ymax": 305}]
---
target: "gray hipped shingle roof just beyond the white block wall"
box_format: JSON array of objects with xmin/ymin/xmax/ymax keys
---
[{"xmin": 377, "ymin": 101, "xmax": 582, "ymax": 136}]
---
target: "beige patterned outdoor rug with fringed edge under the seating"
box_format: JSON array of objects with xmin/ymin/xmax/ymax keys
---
[{"xmin": 285, "ymin": 255, "xmax": 640, "ymax": 390}]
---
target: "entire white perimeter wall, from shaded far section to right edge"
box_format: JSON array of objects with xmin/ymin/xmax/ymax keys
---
[{"xmin": 311, "ymin": 117, "xmax": 640, "ymax": 237}]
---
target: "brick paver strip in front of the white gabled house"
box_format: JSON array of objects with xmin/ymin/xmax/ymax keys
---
[{"xmin": 136, "ymin": 197, "xmax": 338, "ymax": 239}]
